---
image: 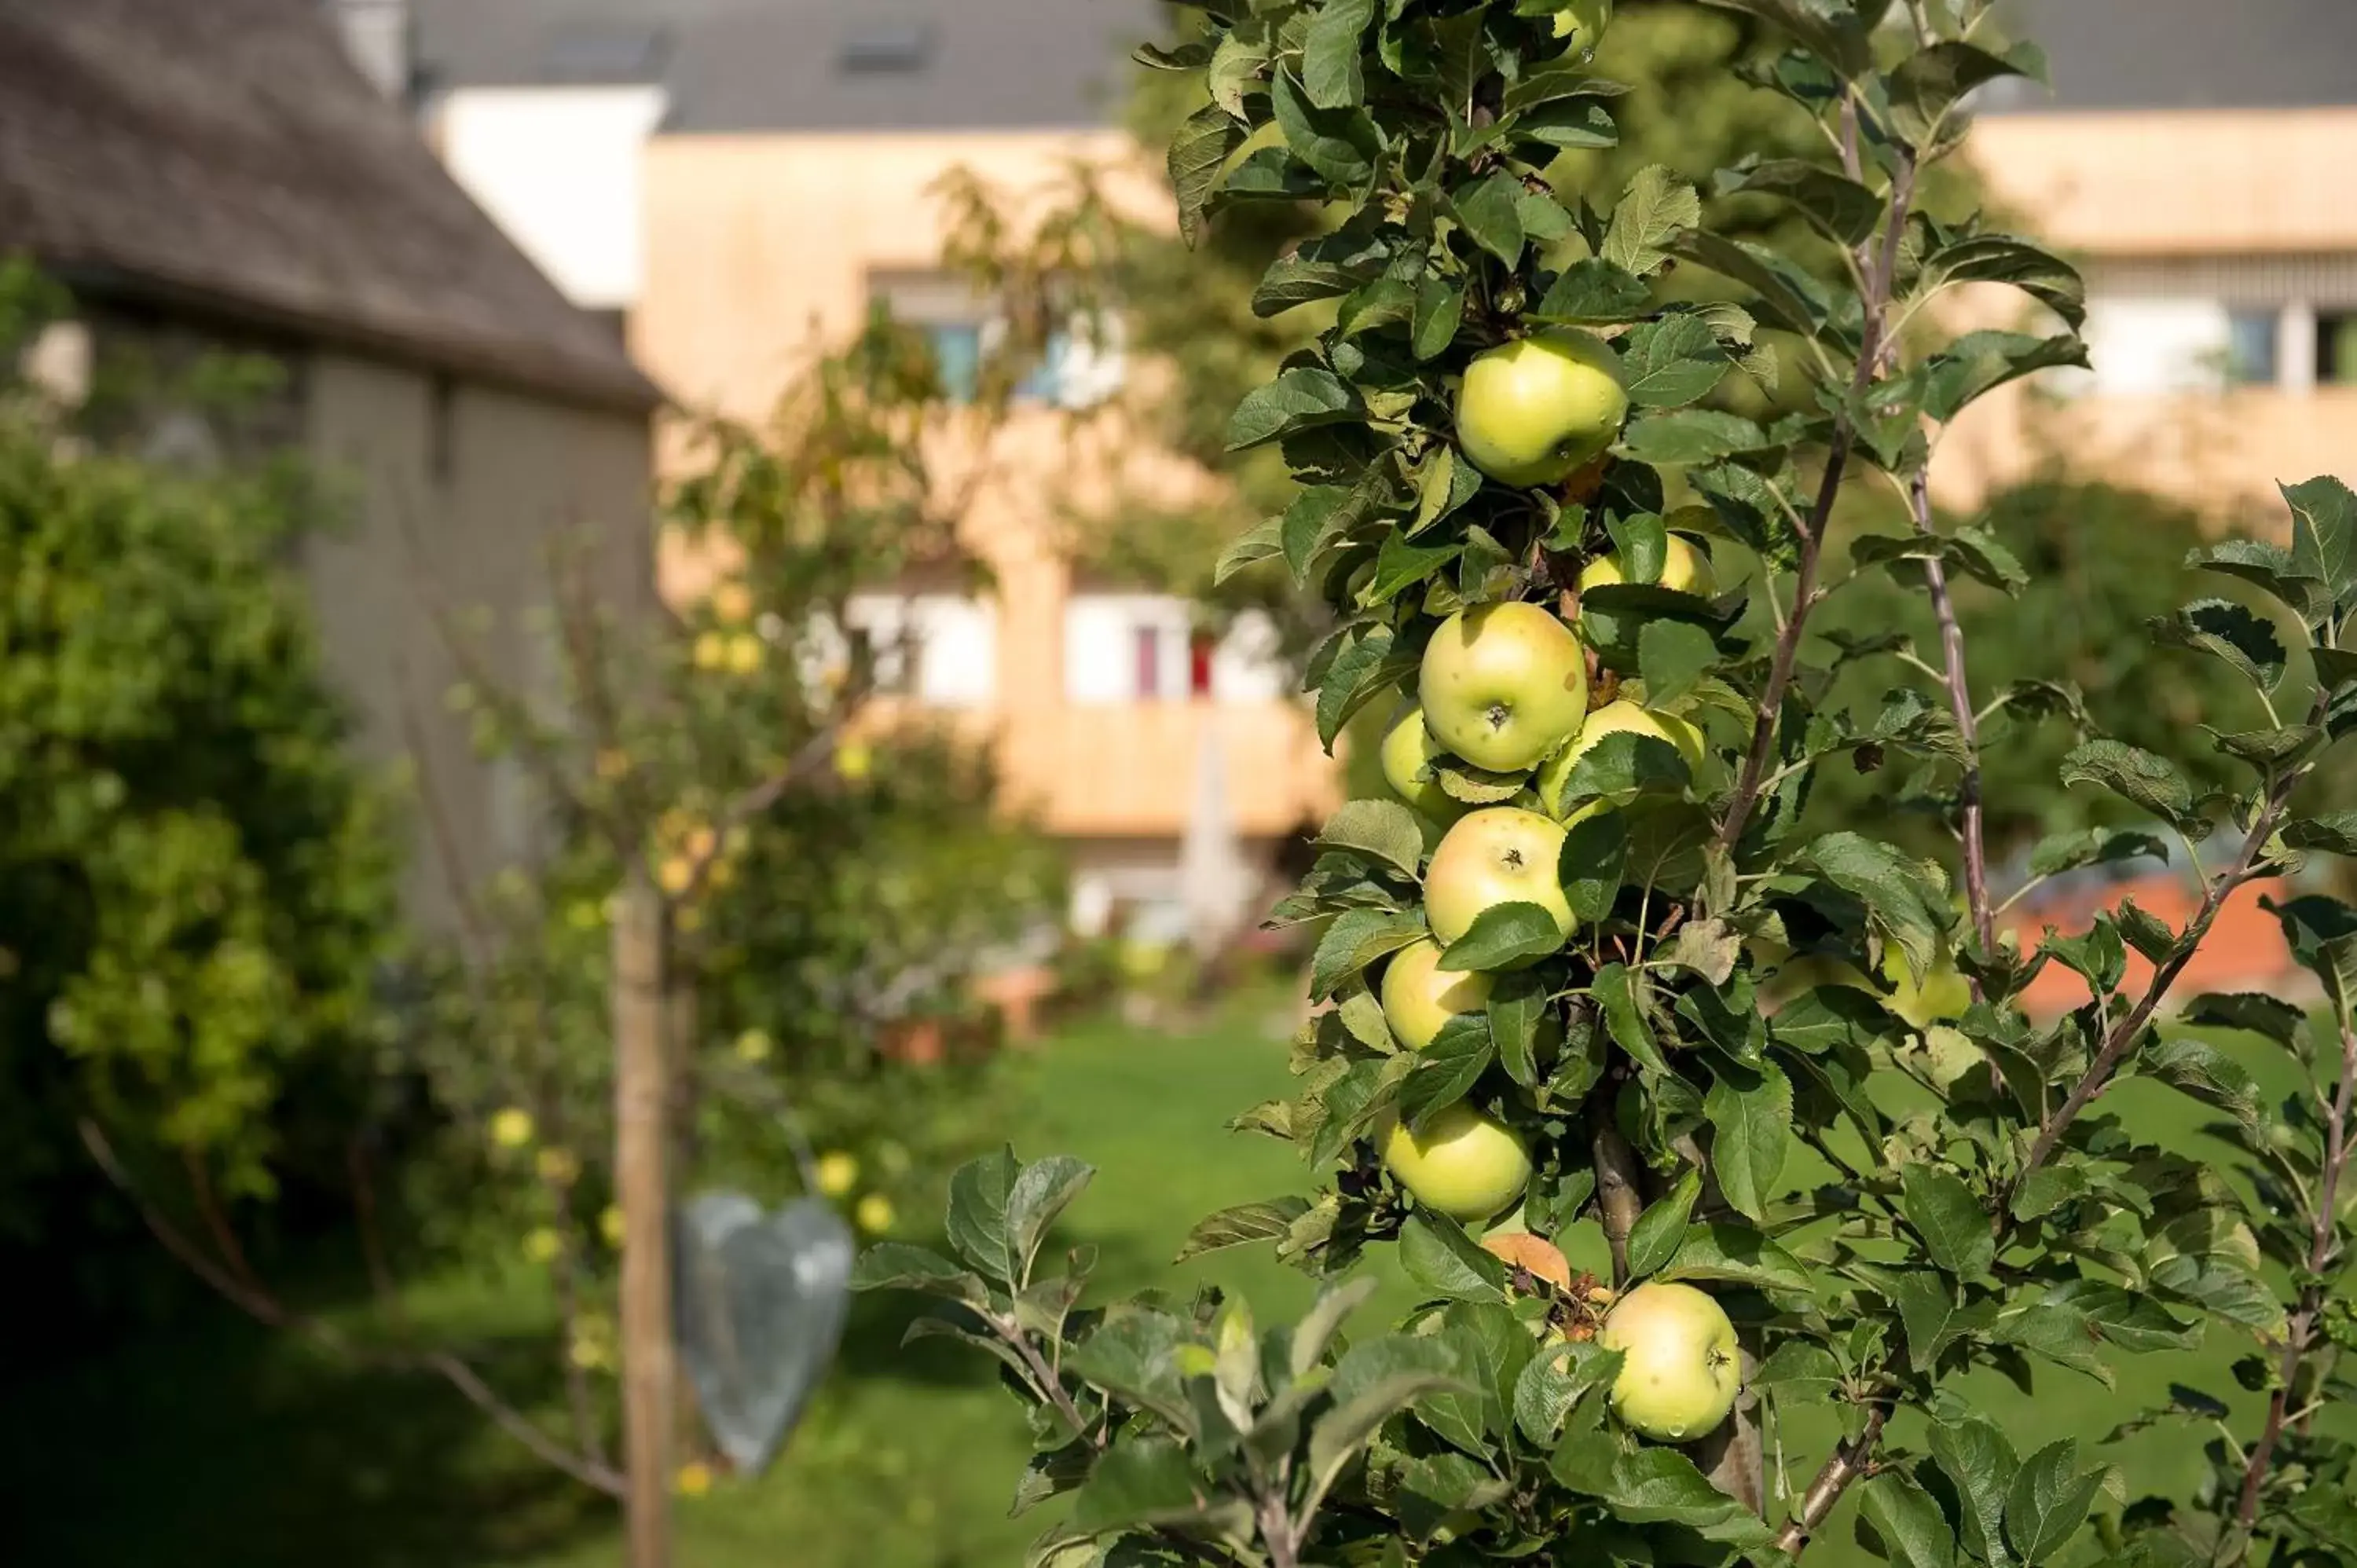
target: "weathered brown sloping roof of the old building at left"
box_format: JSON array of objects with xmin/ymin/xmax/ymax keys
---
[{"xmin": 0, "ymin": 0, "xmax": 660, "ymax": 410}]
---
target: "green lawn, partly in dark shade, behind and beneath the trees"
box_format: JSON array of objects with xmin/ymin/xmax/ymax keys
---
[{"xmin": 0, "ymin": 995, "xmax": 2338, "ymax": 1568}]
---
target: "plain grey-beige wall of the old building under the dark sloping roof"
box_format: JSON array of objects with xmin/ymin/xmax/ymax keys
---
[{"xmin": 304, "ymin": 354, "xmax": 653, "ymax": 929}]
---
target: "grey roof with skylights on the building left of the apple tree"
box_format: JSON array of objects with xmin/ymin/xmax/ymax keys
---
[{"xmin": 415, "ymin": 0, "xmax": 1167, "ymax": 132}]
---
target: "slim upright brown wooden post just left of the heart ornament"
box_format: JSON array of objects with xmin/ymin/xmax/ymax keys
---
[{"xmin": 608, "ymin": 863, "xmax": 676, "ymax": 1568}]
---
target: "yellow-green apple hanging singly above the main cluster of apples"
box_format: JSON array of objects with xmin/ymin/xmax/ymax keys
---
[{"xmin": 1457, "ymin": 328, "xmax": 1629, "ymax": 488}]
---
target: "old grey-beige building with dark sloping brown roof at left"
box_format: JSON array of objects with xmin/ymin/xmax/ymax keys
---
[{"xmin": 0, "ymin": 0, "xmax": 660, "ymax": 925}]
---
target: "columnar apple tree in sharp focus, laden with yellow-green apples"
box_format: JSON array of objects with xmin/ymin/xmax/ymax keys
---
[{"xmin": 860, "ymin": 0, "xmax": 2357, "ymax": 1568}]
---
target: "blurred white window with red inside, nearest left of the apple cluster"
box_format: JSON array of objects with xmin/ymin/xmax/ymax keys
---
[{"xmin": 1063, "ymin": 594, "xmax": 1285, "ymax": 702}]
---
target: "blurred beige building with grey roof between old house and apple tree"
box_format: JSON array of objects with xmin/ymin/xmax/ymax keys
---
[{"xmin": 415, "ymin": 0, "xmax": 1336, "ymax": 934}]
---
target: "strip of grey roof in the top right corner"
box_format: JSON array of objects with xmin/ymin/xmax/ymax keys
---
[{"xmin": 1989, "ymin": 0, "xmax": 2357, "ymax": 111}]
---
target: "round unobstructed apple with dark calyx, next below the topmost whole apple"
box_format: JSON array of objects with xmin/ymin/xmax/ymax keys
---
[{"xmin": 1417, "ymin": 601, "xmax": 1589, "ymax": 773}]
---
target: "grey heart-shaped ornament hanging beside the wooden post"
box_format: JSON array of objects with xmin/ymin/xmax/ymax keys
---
[{"xmin": 672, "ymin": 1191, "xmax": 858, "ymax": 1474}]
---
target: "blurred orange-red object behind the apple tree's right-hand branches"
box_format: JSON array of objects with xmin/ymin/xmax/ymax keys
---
[{"xmin": 2003, "ymin": 875, "xmax": 2303, "ymax": 1019}]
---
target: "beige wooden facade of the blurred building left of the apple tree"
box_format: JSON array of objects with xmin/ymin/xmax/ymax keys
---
[{"xmin": 632, "ymin": 132, "xmax": 1336, "ymax": 856}]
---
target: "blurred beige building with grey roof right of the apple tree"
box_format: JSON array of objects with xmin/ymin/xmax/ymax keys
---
[{"xmin": 1942, "ymin": 0, "xmax": 2357, "ymax": 526}]
